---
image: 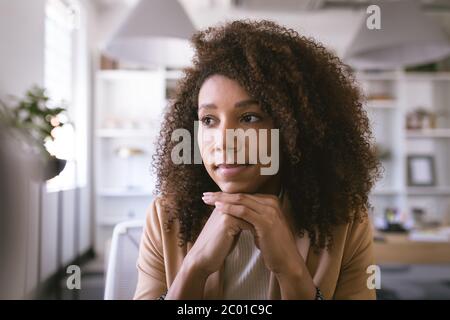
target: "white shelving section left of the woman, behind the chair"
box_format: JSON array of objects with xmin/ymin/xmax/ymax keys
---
[{"xmin": 94, "ymin": 69, "xmax": 182, "ymax": 254}]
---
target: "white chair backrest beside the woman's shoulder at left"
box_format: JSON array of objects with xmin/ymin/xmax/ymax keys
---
[{"xmin": 104, "ymin": 220, "xmax": 144, "ymax": 300}]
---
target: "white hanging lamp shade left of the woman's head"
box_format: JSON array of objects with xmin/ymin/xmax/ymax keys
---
[{"xmin": 105, "ymin": 0, "xmax": 195, "ymax": 68}]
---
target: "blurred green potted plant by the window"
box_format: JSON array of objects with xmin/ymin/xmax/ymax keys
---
[{"xmin": 0, "ymin": 86, "xmax": 67, "ymax": 180}]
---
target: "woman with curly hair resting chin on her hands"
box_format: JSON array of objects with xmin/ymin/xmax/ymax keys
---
[{"xmin": 135, "ymin": 21, "xmax": 380, "ymax": 299}]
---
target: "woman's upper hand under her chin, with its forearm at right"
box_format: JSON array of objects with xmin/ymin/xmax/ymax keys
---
[{"xmin": 203, "ymin": 192, "xmax": 315, "ymax": 299}]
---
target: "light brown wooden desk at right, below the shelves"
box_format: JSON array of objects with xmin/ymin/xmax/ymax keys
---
[{"xmin": 374, "ymin": 232, "xmax": 450, "ymax": 265}]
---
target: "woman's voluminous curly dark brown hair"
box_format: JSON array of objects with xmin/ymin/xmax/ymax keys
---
[{"xmin": 153, "ymin": 20, "xmax": 381, "ymax": 249}]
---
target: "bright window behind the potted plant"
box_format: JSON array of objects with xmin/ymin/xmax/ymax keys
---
[{"xmin": 44, "ymin": 0, "xmax": 80, "ymax": 190}]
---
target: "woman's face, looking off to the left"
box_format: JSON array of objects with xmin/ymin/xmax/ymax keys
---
[{"xmin": 198, "ymin": 75, "xmax": 279, "ymax": 194}]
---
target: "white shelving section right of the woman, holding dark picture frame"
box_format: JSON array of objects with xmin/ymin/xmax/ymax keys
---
[{"xmin": 356, "ymin": 71, "xmax": 450, "ymax": 229}]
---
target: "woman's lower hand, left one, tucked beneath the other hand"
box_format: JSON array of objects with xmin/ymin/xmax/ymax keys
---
[{"xmin": 186, "ymin": 208, "xmax": 251, "ymax": 277}]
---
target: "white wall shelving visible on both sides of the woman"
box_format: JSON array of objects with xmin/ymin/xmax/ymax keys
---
[{"xmin": 91, "ymin": 69, "xmax": 450, "ymax": 253}]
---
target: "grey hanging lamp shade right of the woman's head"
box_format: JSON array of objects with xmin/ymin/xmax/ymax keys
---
[{"xmin": 344, "ymin": 1, "xmax": 450, "ymax": 69}]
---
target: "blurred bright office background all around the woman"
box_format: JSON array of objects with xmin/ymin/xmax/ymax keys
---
[{"xmin": 0, "ymin": 0, "xmax": 450, "ymax": 299}]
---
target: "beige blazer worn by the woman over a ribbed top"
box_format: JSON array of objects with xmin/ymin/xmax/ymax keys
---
[{"xmin": 134, "ymin": 195, "xmax": 375, "ymax": 299}]
